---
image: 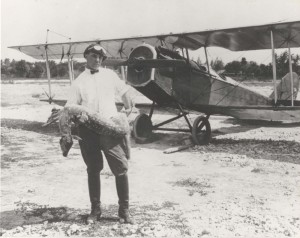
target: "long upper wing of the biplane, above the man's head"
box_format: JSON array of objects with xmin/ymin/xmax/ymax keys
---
[{"xmin": 9, "ymin": 21, "xmax": 300, "ymax": 59}]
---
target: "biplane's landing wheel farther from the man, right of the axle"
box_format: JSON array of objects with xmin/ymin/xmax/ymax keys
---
[{"xmin": 192, "ymin": 116, "xmax": 211, "ymax": 145}]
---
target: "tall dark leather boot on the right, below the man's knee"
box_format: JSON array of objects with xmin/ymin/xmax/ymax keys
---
[{"xmin": 116, "ymin": 174, "xmax": 134, "ymax": 224}]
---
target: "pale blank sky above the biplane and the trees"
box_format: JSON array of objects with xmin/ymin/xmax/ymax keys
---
[{"xmin": 1, "ymin": 0, "xmax": 300, "ymax": 64}]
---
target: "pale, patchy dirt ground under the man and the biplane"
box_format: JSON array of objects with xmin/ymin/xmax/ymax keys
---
[{"xmin": 0, "ymin": 81, "xmax": 300, "ymax": 238}]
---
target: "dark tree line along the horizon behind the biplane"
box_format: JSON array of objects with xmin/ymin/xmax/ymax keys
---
[{"xmin": 1, "ymin": 51, "xmax": 300, "ymax": 79}]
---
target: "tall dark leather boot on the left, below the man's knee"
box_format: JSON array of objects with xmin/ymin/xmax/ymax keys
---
[{"xmin": 86, "ymin": 173, "xmax": 101, "ymax": 224}]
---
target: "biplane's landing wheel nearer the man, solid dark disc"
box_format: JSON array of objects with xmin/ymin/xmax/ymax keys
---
[{"xmin": 133, "ymin": 113, "xmax": 152, "ymax": 144}]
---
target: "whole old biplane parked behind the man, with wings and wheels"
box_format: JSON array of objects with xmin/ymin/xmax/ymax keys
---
[{"xmin": 10, "ymin": 21, "xmax": 300, "ymax": 144}]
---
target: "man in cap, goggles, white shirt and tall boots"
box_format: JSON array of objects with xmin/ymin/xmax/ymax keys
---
[{"xmin": 67, "ymin": 44, "xmax": 132, "ymax": 224}]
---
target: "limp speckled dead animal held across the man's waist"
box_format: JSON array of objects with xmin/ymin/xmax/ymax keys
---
[{"xmin": 59, "ymin": 104, "xmax": 130, "ymax": 159}]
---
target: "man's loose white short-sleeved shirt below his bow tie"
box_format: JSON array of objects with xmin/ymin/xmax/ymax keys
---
[{"xmin": 67, "ymin": 68, "xmax": 129, "ymax": 118}]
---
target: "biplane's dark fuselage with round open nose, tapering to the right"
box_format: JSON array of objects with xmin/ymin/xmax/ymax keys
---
[{"xmin": 127, "ymin": 44, "xmax": 300, "ymax": 121}]
